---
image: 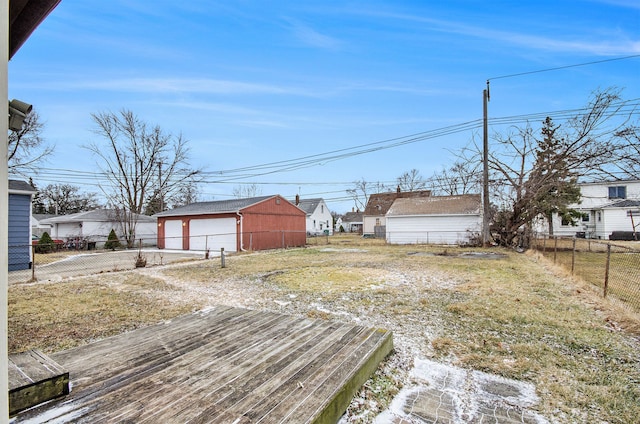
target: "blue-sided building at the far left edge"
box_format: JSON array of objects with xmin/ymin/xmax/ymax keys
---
[{"xmin": 7, "ymin": 180, "xmax": 36, "ymax": 271}]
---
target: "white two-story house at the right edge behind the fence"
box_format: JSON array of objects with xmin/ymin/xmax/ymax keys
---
[{"xmin": 553, "ymin": 180, "xmax": 640, "ymax": 239}]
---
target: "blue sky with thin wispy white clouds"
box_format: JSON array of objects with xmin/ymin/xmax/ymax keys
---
[{"xmin": 9, "ymin": 0, "xmax": 640, "ymax": 212}]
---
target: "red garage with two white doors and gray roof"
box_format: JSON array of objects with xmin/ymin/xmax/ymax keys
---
[{"xmin": 155, "ymin": 195, "xmax": 307, "ymax": 252}]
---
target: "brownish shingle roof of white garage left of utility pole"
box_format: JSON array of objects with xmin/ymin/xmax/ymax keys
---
[{"xmin": 387, "ymin": 194, "xmax": 481, "ymax": 216}]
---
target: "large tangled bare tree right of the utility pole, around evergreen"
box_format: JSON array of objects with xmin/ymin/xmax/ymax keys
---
[{"xmin": 478, "ymin": 89, "xmax": 626, "ymax": 246}]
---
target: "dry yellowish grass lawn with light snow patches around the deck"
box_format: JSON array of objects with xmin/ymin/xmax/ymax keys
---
[{"xmin": 9, "ymin": 236, "xmax": 640, "ymax": 423}]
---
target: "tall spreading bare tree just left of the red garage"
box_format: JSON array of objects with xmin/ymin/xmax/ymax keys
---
[{"xmin": 85, "ymin": 109, "xmax": 200, "ymax": 247}]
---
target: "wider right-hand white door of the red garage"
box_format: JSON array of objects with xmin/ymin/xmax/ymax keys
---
[{"xmin": 189, "ymin": 218, "xmax": 236, "ymax": 252}]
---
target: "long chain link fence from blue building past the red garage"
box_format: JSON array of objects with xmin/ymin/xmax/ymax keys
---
[{"xmin": 8, "ymin": 230, "xmax": 312, "ymax": 284}]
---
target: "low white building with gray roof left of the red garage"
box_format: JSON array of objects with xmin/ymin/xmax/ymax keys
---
[{"xmin": 40, "ymin": 209, "xmax": 158, "ymax": 247}]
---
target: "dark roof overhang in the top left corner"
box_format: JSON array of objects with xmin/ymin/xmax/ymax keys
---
[{"xmin": 9, "ymin": 0, "xmax": 61, "ymax": 59}]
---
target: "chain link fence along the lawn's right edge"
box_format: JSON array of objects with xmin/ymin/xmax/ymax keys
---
[{"xmin": 531, "ymin": 236, "xmax": 640, "ymax": 312}]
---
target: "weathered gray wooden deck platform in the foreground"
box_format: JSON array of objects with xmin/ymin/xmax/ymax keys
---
[{"xmin": 16, "ymin": 306, "xmax": 393, "ymax": 424}]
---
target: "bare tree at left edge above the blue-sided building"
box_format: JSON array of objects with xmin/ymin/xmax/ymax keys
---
[{"xmin": 8, "ymin": 110, "xmax": 53, "ymax": 176}]
